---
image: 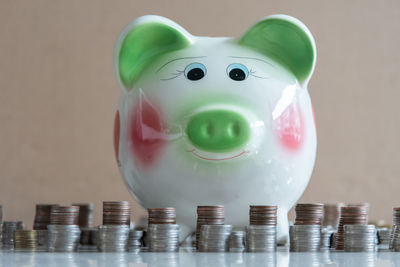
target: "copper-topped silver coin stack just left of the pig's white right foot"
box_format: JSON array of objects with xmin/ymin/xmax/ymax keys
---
[{"xmin": 246, "ymin": 205, "xmax": 278, "ymax": 252}]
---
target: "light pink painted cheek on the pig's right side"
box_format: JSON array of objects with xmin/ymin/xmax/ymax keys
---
[{"xmin": 274, "ymin": 103, "xmax": 304, "ymax": 151}]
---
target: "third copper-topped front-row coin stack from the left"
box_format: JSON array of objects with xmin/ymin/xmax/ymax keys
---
[{"xmin": 147, "ymin": 208, "xmax": 179, "ymax": 252}]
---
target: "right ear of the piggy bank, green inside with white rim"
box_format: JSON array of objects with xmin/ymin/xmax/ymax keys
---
[{"xmin": 239, "ymin": 15, "xmax": 316, "ymax": 85}]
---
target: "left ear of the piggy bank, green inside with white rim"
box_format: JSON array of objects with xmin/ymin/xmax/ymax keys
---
[{"xmin": 114, "ymin": 16, "xmax": 190, "ymax": 90}]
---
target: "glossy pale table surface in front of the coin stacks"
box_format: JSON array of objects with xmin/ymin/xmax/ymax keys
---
[{"xmin": 0, "ymin": 250, "xmax": 400, "ymax": 267}]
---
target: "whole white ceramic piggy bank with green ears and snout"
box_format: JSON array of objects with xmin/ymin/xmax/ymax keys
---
[{"xmin": 114, "ymin": 15, "xmax": 316, "ymax": 245}]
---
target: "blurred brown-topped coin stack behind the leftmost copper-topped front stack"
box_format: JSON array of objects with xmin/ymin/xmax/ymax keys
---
[{"xmin": 33, "ymin": 204, "xmax": 59, "ymax": 248}]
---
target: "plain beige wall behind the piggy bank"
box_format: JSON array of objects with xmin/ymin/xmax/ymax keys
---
[{"xmin": 0, "ymin": 0, "xmax": 400, "ymax": 227}]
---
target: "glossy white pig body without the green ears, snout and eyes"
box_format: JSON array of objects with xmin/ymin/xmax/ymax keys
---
[{"xmin": 116, "ymin": 15, "xmax": 316, "ymax": 245}]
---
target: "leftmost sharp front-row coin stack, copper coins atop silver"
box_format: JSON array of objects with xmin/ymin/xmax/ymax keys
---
[{"xmin": 47, "ymin": 206, "xmax": 81, "ymax": 252}]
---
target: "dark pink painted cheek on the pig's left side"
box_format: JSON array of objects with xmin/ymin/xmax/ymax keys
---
[{"xmin": 130, "ymin": 97, "xmax": 166, "ymax": 167}]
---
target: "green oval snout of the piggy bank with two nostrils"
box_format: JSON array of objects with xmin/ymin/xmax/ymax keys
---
[{"xmin": 186, "ymin": 110, "xmax": 250, "ymax": 152}]
